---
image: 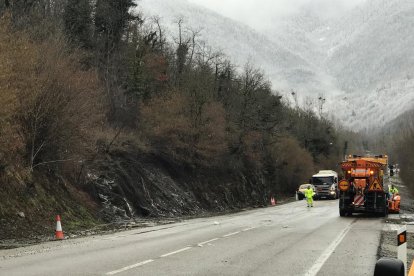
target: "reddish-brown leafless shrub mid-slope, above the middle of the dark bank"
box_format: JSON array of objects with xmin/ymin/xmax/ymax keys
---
[{"xmin": 141, "ymin": 91, "xmax": 227, "ymax": 165}]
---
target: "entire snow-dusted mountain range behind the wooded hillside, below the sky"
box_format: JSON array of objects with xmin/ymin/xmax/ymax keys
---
[{"xmin": 138, "ymin": 0, "xmax": 414, "ymax": 129}]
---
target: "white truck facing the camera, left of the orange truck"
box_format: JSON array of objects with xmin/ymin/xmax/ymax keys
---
[{"xmin": 310, "ymin": 170, "xmax": 338, "ymax": 199}]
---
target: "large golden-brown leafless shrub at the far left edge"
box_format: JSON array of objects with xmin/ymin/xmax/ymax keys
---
[{"xmin": 0, "ymin": 15, "xmax": 103, "ymax": 170}]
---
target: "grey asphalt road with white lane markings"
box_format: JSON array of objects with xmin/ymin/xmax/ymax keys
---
[{"xmin": 0, "ymin": 200, "xmax": 382, "ymax": 276}]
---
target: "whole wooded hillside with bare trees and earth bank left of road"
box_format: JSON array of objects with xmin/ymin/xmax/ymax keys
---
[{"xmin": 0, "ymin": 0, "xmax": 368, "ymax": 238}]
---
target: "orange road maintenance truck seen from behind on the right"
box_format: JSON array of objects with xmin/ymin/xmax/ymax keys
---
[{"xmin": 338, "ymin": 155, "xmax": 389, "ymax": 216}]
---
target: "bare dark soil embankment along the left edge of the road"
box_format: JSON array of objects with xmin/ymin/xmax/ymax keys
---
[{"xmin": 0, "ymin": 149, "xmax": 282, "ymax": 248}]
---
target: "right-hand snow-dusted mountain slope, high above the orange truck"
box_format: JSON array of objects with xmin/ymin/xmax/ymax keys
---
[{"xmin": 320, "ymin": 0, "xmax": 414, "ymax": 129}]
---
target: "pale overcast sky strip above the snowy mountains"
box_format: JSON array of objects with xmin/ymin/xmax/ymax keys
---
[{"xmin": 189, "ymin": 0, "xmax": 365, "ymax": 28}]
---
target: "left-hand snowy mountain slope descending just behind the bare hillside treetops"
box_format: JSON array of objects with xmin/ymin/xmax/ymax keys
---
[{"xmin": 138, "ymin": 0, "xmax": 342, "ymax": 99}]
